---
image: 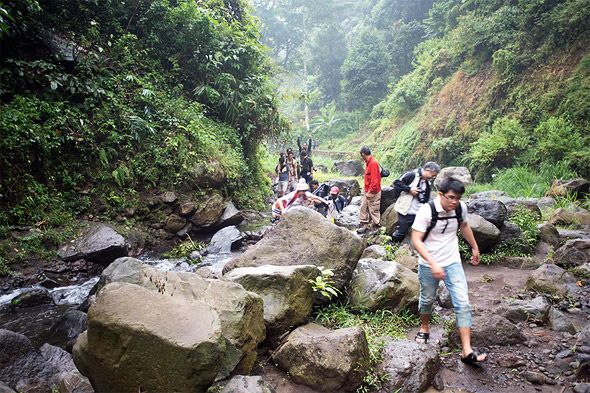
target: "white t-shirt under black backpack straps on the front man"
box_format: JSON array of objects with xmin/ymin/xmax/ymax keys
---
[{"xmin": 412, "ymin": 196, "xmax": 467, "ymax": 267}]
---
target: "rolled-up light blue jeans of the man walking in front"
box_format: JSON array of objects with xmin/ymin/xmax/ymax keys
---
[{"xmin": 418, "ymin": 262, "xmax": 472, "ymax": 328}]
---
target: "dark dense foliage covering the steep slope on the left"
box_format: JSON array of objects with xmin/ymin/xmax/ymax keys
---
[{"xmin": 0, "ymin": 0, "xmax": 287, "ymax": 225}]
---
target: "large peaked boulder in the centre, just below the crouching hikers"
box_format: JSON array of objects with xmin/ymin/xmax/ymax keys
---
[{"xmin": 223, "ymin": 207, "xmax": 366, "ymax": 290}]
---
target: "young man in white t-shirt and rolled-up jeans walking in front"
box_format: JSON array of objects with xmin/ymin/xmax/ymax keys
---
[{"xmin": 412, "ymin": 178, "xmax": 487, "ymax": 366}]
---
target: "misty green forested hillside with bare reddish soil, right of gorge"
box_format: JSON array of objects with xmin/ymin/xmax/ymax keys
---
[{"xmin": 255, "ymin": 0, "xmax": 590, "ymax": 181}]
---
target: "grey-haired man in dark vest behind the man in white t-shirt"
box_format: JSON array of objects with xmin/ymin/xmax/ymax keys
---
[{"xmin": 391, "ymin": 162, "xmax": 440, "ymax": 242}]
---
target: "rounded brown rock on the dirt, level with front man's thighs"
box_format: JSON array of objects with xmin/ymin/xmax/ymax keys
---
[{"xmin": 526, "ymin": 263, "xmax": 576, "ymax": 297}]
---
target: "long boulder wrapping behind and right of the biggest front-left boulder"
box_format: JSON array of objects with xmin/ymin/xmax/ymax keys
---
[{"xmin": 98, "ymin": 258, "xmax": 265, "ymax": 378}]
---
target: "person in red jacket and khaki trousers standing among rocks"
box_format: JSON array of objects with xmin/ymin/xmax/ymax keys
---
[{"xmin": 357, "ymin": 146, "xmax": 381, "ymax": 234}]
